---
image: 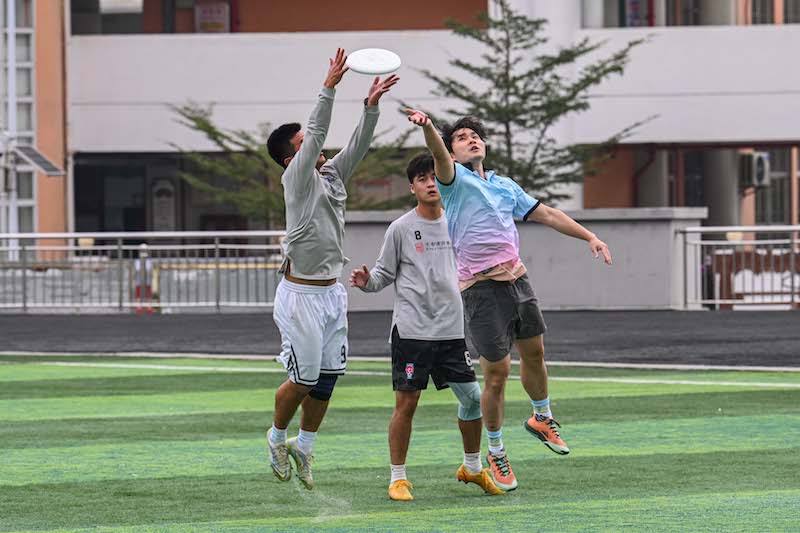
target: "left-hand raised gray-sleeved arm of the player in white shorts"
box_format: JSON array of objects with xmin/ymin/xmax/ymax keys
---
[{"xmin": 283, "ymin": 48, "xmax": 347, "ymax": 193}]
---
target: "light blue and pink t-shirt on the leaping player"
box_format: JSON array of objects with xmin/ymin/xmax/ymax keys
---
[{"xmin": 436, "ymin": 163, "xmax": 539, "ymax": 281}]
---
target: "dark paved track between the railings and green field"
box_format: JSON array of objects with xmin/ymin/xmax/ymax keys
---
[{"xmin": 0, "ymin": 311, "xmax": 800, "ymax": 366}]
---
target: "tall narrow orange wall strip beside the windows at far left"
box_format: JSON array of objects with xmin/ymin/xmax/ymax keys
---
[{"xmin": 34, "ymin": 0, "xmax": 67, "ymax": 232}]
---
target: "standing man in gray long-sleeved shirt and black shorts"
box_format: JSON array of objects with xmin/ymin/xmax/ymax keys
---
[{"xmin": 350, "ymin": 152, "xmax": 503, "ymax": 501}]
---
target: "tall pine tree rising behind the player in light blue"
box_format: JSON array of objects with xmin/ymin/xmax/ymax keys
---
[{"xmin": 422, "ymin": 0, "xmax": 649, "ymax": 203}]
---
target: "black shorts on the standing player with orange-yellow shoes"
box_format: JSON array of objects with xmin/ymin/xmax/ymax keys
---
[{"xmin": 392, "ymin": 326, "xmax": 477, "ymax": 391}]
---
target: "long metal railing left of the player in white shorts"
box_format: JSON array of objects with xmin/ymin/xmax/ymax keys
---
[{"xmin": 0, "ymin": 231, "xmax": 285, "ymax": 313}]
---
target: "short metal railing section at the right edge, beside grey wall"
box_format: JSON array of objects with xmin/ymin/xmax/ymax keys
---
[{"xmin": 679, "ymin": 226, "xmax": 800, "ymax": 309}]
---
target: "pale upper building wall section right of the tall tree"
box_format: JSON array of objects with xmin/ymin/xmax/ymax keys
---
[{"xmin": 571, "ymin": 24, "xmax": 800, "ymax": 143}]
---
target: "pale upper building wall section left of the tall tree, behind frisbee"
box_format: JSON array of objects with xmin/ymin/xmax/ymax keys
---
[{"xmin": 68, "ymin": 30, "xmax": 478, "ymax": 152}]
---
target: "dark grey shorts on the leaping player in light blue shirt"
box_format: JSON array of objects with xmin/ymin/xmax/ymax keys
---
[{"xmin": 461, "ymin": 274, "xmax": 547, "ymax": 362}]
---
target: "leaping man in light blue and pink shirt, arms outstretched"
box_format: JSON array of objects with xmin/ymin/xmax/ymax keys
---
[{"xmin": 406, "ymin": 109, "xmax": 611, "ymax": 490}]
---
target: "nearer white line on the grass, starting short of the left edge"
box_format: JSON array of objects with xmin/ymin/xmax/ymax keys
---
[{"xmin": 38, "ymin": 361, "xmax": 800, "ymax": 389}]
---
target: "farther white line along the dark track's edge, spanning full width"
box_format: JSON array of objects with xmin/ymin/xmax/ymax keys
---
[{"xmin": 0, "ymin": 351, "xmax": 800, "ymax": 372}]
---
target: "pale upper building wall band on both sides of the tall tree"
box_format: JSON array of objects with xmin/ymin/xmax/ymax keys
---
[{"xmin": 69, "ymin": 24, "xmax": 800, "ymax": 152}]
